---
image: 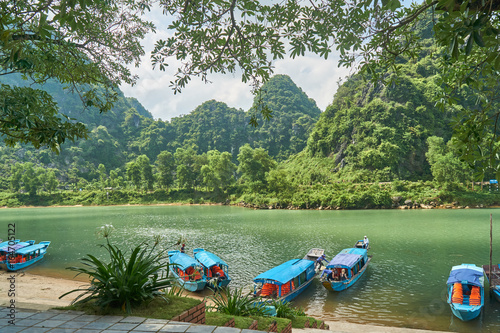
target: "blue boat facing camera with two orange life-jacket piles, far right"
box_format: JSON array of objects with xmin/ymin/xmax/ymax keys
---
[{"xmin": 446, "ymin": 264, "xmax": 484, "ymax": 321}]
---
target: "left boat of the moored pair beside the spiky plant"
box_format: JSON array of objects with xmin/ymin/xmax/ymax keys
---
[{"xmin": 168, "ymin": 250, "xmax": 207, "ymax": 291}]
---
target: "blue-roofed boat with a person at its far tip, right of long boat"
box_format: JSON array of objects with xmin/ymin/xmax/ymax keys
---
[{"xmin": 321, "ymin": 248, "xmax": 371, "ymax": 291}]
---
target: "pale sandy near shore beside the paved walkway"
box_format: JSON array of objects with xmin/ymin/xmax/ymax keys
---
[{"xmin": 0, "ymin": 271, "xmax": 452, "ymax": 333}]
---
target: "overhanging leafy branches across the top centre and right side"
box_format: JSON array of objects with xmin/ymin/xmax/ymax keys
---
[{"xmin": 152, "ymin": 0, "xmax": 500, "ymax": 171}]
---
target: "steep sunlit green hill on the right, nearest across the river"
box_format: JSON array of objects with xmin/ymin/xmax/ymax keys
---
[{"xmin": 296, "ymin": 41, "xmax": 458, "ymax": 181}]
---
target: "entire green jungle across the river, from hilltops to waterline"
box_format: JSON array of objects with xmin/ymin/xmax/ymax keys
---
[{"xmin": 0, "ymin": 22, "xmax": 499, "ymax": 209}]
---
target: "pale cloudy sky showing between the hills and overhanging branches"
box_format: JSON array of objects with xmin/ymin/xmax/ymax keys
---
[{"xmin": 120, "ymin": 10, "xmax": 350, "ymax": 121}]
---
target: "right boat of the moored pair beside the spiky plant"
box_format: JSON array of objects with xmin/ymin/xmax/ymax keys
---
[{"xmin": 193, "ymin": 248, "xmax": 231, "ymax": 288}]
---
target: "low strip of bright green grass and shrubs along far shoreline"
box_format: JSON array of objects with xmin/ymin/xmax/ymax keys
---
[{"xmin": 0, "ymin": 181, "xmax": 500, "ymax": 209}]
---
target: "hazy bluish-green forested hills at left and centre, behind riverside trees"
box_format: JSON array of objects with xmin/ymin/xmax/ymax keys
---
[{"xmin": 0, "ymin": 75, "xmax": 320, "ymax": 188}]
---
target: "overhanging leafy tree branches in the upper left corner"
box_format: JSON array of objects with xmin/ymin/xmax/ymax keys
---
[{"xmin": 0, "ymin": 0, "xmax": 154, "ymax": 151}]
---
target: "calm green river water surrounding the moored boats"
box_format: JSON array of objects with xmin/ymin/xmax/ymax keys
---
[{"xmin": 0, "ymin": 206, "xmax": 500, "ymax": 332}]
